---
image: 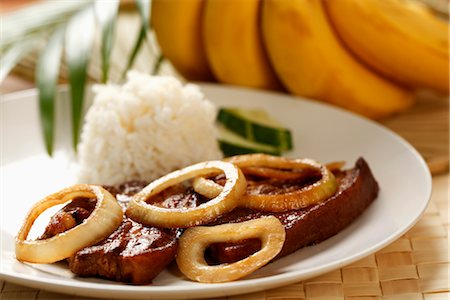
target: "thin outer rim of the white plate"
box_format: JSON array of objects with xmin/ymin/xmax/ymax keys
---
[{"xmin": 0, "ymin": 82, "xmax": 432, "ymax": 298}]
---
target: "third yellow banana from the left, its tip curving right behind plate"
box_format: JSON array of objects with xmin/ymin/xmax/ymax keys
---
[{"xmin": 262, "ymin": 0, "xmax": 413, "ymax": 118}]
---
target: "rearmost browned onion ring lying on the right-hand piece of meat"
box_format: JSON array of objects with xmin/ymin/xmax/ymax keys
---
[{"xmin": 194, "ymin": 154, "xmax": 338, "ymax": 212}]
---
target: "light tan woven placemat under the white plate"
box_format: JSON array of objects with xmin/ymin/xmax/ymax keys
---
[{"xmin": 0, "ymin": 175, "xmax": 450, "ymax": 300}]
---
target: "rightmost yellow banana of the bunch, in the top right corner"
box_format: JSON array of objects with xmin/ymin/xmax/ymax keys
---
[{"xmin": 324, "ymin": 0, "xmax": 449, "ymax": 94}]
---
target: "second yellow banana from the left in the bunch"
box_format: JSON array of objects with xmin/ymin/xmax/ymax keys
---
[{"xmin": 202, "ymin": 0, "xmax": 281, "ymax": 89}]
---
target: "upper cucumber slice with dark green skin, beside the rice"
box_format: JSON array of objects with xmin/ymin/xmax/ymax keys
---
[{"xmin": 217, "ymin": 108, "xmax": 292, "ymax": 150}]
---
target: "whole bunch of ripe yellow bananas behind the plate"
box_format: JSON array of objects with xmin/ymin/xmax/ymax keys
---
[{"xmin": 152, "ymin": 0, "xmax": 449, "ymax": 118}]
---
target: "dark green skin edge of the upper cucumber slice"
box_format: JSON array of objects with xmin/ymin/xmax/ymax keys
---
[{"xmin": 217, "ymin": 108, "xmax": 292, "ymax": 151}]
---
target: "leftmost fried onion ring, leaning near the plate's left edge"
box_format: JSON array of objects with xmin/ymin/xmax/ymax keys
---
[{"xmin": 16, "ymin": 184, "xmax": 123, "ymax": 263}]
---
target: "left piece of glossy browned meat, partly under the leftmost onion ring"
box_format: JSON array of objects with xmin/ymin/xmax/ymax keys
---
[{"xmin": 41, "ymin": 182, "xmax": 192, "ymax": 284}]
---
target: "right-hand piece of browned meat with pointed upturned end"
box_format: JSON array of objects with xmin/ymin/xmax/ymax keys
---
[{"xmin": 208, "ymin": 158, "xmax": 378, "ymax": 263}]
